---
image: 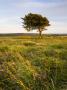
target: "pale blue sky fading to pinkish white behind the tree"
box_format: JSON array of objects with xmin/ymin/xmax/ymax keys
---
[{"xmin": 0, "ymin": 0, "xmax": 67, "ymax": 34}]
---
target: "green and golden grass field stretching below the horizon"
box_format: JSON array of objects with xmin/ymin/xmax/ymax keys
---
[{"xmin": 0, "ymin": 36, "xmax": 67, "ymax": 90}]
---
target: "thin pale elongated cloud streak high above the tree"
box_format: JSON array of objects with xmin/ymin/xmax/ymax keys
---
[{"xmin": 15, "ymin": 1, "xmax": 56, "ymax": 8}]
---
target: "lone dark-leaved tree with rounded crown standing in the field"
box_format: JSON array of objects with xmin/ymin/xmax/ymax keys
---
[{"xmin": 21, "ymin": 13, "xmax": 50, "ymax": 37}]
